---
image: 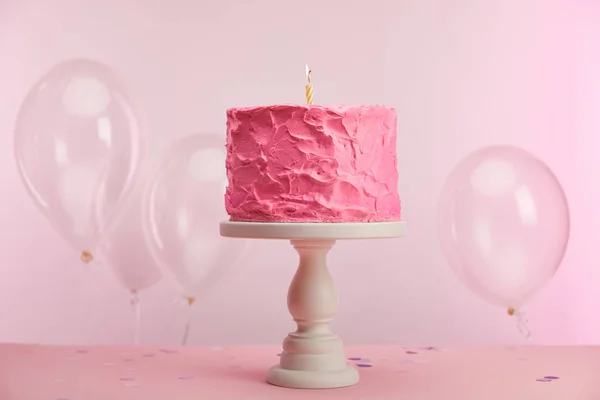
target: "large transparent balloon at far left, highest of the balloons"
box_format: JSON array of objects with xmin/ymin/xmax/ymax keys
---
[{"xmin": 14, "ymin": 59, "xmax": 143, "ymax": 261}]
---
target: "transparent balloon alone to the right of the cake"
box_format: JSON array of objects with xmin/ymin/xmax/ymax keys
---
[{"xmin": 438, "ymin": 146, "xmax": 569, "ymax": 314}]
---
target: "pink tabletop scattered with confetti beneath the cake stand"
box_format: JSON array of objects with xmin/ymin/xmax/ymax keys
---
[{"xmin": 0, "ymin": 344, "xmax": 600, "ymax": 400}]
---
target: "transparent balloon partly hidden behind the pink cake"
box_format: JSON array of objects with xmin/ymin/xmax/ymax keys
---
[{"xmin": 144, "ymin": 135, "xmax": 248, "ymax": 302}]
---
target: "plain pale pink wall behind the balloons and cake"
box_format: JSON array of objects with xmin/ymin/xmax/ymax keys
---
[{"xmin": 0, "ymin": 0, "xmax": 600, "ymax": 344}]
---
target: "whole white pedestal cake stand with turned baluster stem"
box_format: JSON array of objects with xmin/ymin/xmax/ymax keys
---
[{"xmin": 221, "ymin": 221, "xmax": 405, "ymax": 389}]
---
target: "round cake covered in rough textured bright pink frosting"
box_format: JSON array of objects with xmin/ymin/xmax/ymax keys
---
[{"xmin": 225, "ymin": 105, "xmax": 400, "ymax": 222}]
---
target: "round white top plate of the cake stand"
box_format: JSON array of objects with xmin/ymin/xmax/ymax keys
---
[{"xmin": 220, "ymin": 221, "xmax": 406, "ymax": 239}]
